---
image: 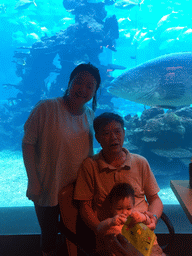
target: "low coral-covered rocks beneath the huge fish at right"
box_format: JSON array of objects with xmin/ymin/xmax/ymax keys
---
[{"xmin": 125, "ymin": 107, "xmax": 192, "ymax": 164}]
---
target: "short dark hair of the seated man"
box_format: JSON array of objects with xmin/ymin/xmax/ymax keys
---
[{"xmin": 93, "ymin": 112, "xmax": 124, "ymax": 134}]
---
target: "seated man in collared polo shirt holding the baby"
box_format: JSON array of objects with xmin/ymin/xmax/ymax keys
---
[{"xmin": 74, "ymin": 112, "xmax": 163, "ymax": 255}]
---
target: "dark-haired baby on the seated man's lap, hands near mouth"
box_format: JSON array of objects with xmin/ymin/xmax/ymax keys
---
[{"xmin": 97, "ymin": 183, "xmax": 165, "ymax": 256}]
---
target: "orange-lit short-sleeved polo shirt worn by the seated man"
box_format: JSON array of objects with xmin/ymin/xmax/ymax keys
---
[{"xmin": 74, "ymin": 148, "xmax": 160, "ymax": 221}]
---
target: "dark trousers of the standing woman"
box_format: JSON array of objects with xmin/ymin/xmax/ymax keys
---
[{"xmin": 35, "ymin": 204, "xmax": 60, "ymax": 252}]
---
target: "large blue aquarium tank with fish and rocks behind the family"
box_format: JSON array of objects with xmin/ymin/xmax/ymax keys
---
[{"xmin": 0, "ymin": 0, "xmax": 192, "ymax": 207}]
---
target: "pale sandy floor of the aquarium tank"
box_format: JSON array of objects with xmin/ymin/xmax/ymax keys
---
[{"xmin": 0, "ymin": 150, "xmax": 178, "ymax": 207}]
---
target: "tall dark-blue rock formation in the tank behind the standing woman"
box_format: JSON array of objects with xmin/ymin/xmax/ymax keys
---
[{"xmin": 0, "ymin": 0, "xmax": 120, "ymax": 150}]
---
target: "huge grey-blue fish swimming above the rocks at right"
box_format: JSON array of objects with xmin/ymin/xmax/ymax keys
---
[{"xmin": 108, "ymin": 52, "xmax": 192, "ymax": 108}]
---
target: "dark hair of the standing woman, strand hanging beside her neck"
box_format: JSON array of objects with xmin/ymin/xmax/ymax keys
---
[{"xmin": 64, "ymin": 62, "xmax": 101, "ymax": 111}]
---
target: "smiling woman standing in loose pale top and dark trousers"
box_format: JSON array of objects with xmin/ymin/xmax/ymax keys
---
[{"xmin": 22, "ymin": 63, "xmax": 101, "ymax": 255}]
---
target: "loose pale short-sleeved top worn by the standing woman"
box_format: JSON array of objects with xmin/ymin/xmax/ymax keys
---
[{"xmin": 23, "ymin": 97, "xmax": 94, "ymax": 206}]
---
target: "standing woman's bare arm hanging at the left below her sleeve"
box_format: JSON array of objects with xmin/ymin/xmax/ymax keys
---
[{"xmin": 22, "ymin": 143, "xmax": 41, "ymax": 202}]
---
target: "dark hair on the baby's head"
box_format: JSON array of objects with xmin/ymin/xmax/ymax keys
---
[{"xmin": 107, "ymin": 183, "xmax": 135, "ymax": 205}]
